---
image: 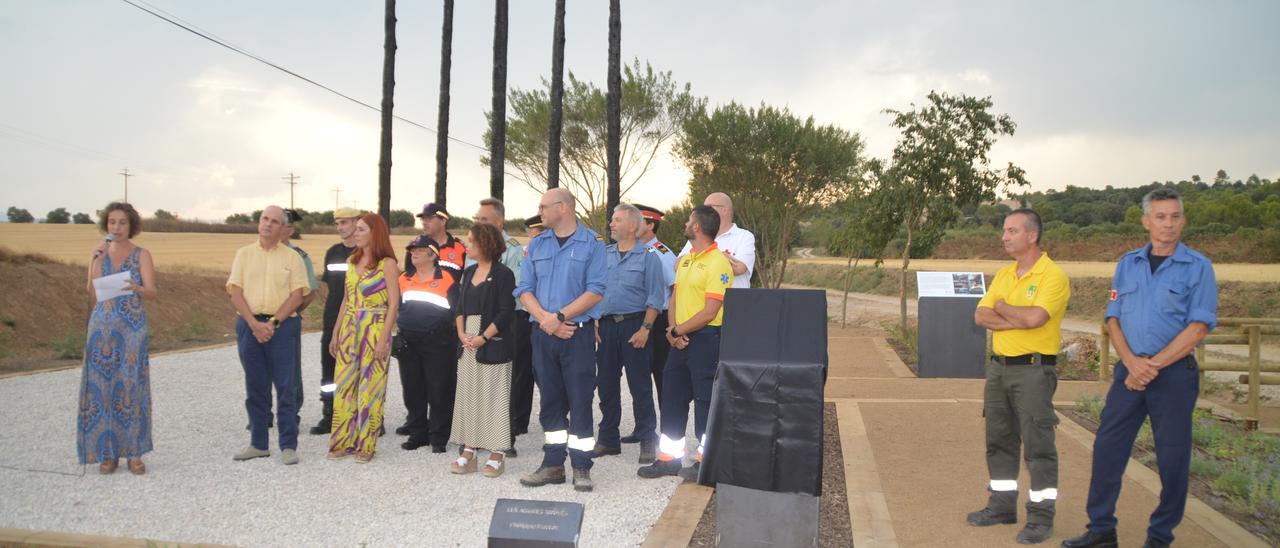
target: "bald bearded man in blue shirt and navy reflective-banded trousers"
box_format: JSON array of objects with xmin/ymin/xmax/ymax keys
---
[{"xmin": 512, "ymin": 188, "xmax": 605, "ymax": 492}]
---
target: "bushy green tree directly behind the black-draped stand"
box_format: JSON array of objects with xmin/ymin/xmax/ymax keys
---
[{"xmin": 675, "ymin": 102, "xmax": 863, "ymax": 287}]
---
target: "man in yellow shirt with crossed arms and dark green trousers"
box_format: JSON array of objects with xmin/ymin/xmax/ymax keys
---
[{"xmin": 968, "ymin": 209, "xmax": 1071, "ymax": 544}]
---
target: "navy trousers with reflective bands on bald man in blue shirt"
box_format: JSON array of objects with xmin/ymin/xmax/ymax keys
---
[{"xmin": 532, "ymin": 324, "xmax": 595, "ymax": 470}]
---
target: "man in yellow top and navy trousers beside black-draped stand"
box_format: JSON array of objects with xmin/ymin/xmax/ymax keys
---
[{"xmin": 636, "ymin": 205, "xmax": 733, "ymax": 479}]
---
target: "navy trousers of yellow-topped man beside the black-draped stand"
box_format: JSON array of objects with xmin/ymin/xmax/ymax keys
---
[{"xmin": 662, "ymin": 325, "xmax": 719, "ymax": 443}]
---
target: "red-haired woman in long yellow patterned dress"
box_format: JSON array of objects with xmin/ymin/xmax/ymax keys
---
[{"xmin": 329, "ymin": 214, "xmax": 399, "ymax": 463}]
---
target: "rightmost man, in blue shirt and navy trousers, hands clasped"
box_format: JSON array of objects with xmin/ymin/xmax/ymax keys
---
[{"xmin": 1062, "ymin": 188, "xmax": 1217, "ymax": 548}]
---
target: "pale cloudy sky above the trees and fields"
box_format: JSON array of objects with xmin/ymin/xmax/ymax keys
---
[{"xmin": 0, "ymin": 0, "xmax": 1280, "ymax": 219}]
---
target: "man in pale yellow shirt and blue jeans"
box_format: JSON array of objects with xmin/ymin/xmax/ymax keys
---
[{"xmin": 227, "ymin": 206, "xmax": 311, "ymax": 465}]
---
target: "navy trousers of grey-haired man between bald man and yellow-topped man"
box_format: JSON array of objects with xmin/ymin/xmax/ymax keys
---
[{"xmin": 595, "ymin": 318, "xmax": 658, "ymax": 447}]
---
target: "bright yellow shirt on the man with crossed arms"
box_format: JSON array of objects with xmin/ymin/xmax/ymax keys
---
[{"xmin": 978, "ymin": 252, "xmax": 1071, "ymax": 356}]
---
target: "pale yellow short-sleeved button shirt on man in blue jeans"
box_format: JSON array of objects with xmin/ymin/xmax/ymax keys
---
[{"xmin": 227, "ymin": 242, "xmax": 311, "ymax": 314}]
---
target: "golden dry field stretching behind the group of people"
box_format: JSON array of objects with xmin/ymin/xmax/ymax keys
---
[{"xmin": 0, "ymin": 223, "xmax": 1280, "ymax": 282}]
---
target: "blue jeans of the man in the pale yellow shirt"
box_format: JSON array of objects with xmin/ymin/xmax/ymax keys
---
[{"xmin": 236, "ymin": 318, "xmax": 302, "ymax": 449}]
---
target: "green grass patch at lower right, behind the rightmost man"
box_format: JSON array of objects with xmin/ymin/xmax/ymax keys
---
[{"xmin": 1075, "ymin": 396, "xmax": 1280, "ymax": 544}]
